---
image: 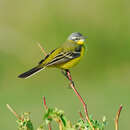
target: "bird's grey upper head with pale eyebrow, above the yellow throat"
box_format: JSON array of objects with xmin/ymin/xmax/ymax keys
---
[{"xmin": 68, "ymin": 32, "xmax": 87, "ymax": 42}]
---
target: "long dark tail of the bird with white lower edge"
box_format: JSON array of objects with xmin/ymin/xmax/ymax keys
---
[{"xmin": 18, "ymin": 66, "xmax": 43, "ymax": 78}]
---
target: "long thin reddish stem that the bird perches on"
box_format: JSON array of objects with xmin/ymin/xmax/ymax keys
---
[{"xmin": 65, "ymin": 70, "xmax": 95, "ymax": 130}]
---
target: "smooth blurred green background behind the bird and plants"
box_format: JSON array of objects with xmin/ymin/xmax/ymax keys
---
[{"xmin": 0, "ymin": 0, "xmax": 130, "ymax": 130}]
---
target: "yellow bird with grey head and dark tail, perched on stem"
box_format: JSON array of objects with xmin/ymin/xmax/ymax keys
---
[{"xmin": 18, "ymin": 32, "xmax": 87, "ymax": 78}]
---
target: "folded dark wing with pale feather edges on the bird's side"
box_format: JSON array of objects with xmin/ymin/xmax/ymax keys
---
[{"xmin": 46, "ymin": 51, "xmax": 80, "ymax": 66}]
